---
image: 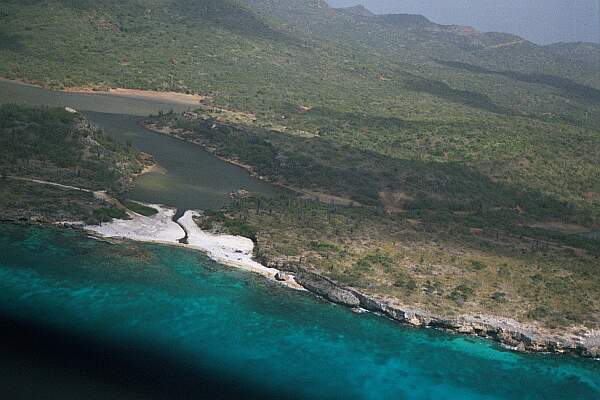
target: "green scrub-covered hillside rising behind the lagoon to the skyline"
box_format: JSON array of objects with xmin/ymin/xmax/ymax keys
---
[{"xmin": 0, "ymin": 0, "xmax": 600, "ymax": 222}]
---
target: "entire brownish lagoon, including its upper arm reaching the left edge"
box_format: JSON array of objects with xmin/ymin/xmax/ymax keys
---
[{"xmin": 0, "ymin": 80, "xmax": 278, "ymax": 210}]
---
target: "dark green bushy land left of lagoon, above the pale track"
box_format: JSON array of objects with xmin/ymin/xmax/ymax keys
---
[{"xmin": 0, "ymin": 104, "xmax": 140, "ymax": 191}]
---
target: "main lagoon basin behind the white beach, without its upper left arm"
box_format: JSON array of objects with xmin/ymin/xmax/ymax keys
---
[{"xmin": 84, "ymin": 111, "xmax": 277, "ymax": 211}]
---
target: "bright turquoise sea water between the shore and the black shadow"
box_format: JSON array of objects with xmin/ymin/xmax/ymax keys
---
[{"xmin": 0, "ymin": 225, "xmax": 600, "ymax": 399}]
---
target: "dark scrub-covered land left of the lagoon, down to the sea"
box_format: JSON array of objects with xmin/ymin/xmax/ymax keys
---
[{"xmin": 0, "ymin": 104, "xmax": 146, "ymax": 223}]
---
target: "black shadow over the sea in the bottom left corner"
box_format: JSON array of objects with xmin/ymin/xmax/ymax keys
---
[{"xmin": 0, "ymin": 315, "xmax": 298, "ymax": 400}]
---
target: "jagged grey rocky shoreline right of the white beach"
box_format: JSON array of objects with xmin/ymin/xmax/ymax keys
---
[{"xmin": 264, "ymin": 260, "xmax": 600, "ymax": 358}]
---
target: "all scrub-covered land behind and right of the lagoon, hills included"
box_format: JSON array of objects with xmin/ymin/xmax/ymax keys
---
[{"xmin": 0, "ymin": 0, "xmax": 600, "ymax": 327}]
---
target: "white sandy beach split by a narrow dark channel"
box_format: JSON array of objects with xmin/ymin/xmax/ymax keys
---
[{"xmin": 84, "ymin": 204, "xmax": 303, "ymax": 289}]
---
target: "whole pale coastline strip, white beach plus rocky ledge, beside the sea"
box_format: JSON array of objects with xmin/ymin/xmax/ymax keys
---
[{"xmin": 2, "ymin": 204, "xmax": 600, "ymax": 359}]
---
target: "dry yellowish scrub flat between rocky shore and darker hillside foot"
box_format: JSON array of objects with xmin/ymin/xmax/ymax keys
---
[{"xmin": 200, "ymin": 195, "xmax": 600, "ymax": 329}]
